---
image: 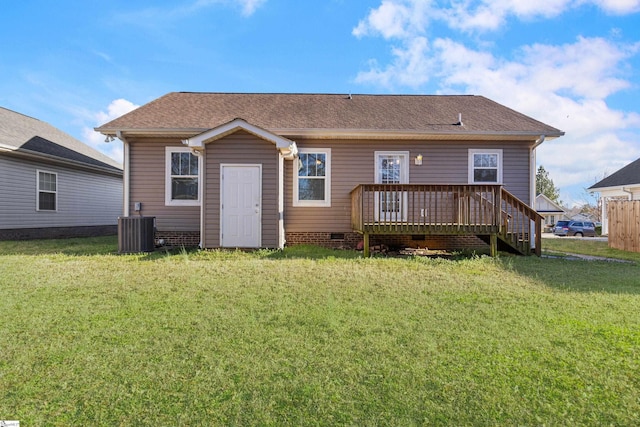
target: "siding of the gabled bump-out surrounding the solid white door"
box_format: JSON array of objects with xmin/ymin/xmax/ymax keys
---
[{"xmin": 203, "ymin": 132, "xmax": 279, "ymax": 248}]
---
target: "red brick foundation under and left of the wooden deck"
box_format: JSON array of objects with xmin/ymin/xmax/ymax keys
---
[{"xmin": 286, "ymin": 232, "xmax": 489, "ymax": 250}]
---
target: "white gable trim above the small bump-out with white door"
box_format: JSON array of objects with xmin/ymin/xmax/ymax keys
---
[{"xmin": 182, "ymin": 119, "xmax": 298, "ymax": 159}]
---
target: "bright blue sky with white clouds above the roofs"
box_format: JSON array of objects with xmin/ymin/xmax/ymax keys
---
[{"xmin": 0, "ymin": 0, "xmax": 640, "ymax": 207}]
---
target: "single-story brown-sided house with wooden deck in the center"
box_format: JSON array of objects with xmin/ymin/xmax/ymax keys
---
[{"xmin": 96, "ymin": 92, "xmax": 563, "ymax": 253}]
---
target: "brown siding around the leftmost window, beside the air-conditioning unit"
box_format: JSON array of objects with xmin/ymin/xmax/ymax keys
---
[{"xmin": 129, "ymin": 139, "xmax": 200, "ymax": 231}]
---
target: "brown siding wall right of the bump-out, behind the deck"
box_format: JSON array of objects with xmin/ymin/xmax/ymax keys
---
[{"xmin": 284, "ymin": 140, "xmax": 530, "ymax": 232}]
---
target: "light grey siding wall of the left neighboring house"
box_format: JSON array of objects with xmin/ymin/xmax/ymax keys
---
[{"xmin": 0, "ymin": 155, "xmax": 122, "ymax": 229}]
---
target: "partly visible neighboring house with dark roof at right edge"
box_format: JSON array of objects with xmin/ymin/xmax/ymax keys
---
[{"xmin": 588, "ymin": 159, "xmax": 640, "ymax": 235}]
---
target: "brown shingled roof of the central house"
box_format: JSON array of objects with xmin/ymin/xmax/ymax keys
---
[{"xmin": 96, "ymin": 92, "xmax": 564, "ymax": 138}]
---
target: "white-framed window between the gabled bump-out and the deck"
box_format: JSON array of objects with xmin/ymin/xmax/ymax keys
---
[{"xmin": 293, "ymin": 148, "xmax": 331, "ymax": 207}]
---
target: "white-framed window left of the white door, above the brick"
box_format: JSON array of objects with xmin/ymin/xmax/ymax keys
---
[{"xmin": 165, "ymin": 147, "xmax": 201, "ymax": 206}]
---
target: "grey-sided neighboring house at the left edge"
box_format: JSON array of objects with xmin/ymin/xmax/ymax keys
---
[{"xmin": 0, "ymin": 107, "xmax": 123, "ymax": 240}]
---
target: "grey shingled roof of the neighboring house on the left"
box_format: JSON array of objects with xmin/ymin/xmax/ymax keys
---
[{"xmin": 0, "ymin": 107, "xmax": 122, "ymax": 171}]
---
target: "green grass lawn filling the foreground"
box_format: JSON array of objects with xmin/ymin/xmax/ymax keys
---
[{"xmin": 0, "ymin": 238, "xmax": 640, "ymax": 426}]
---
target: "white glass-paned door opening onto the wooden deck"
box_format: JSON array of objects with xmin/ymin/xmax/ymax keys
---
[{"xmin": 375, "ymin": 151, "xmax": 409, "ymax": 221}]
